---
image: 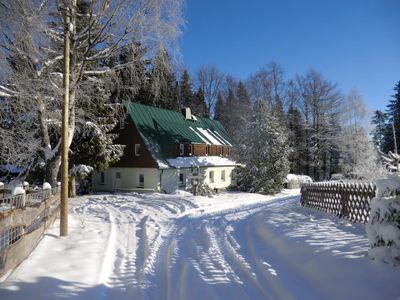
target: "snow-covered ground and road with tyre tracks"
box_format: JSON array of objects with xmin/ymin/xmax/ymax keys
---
[{"xmin": 0, "ymin": 190, "xmax": 400, "ymax": 300}]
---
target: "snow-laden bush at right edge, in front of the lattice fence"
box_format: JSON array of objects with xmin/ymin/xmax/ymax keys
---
[{"xmin": 366, "ymin": 173, "xmax": 400, "ymax": 265}]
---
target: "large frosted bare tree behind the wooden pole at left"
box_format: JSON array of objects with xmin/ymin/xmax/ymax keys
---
[{"xmin": 0, "ymin": 0, "xmax": 182, "ymax": 183}]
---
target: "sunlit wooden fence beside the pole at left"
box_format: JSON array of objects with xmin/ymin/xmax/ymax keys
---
[{"xmin": 0, "ymin": 187, "xmax": 60, "ymax": 277}]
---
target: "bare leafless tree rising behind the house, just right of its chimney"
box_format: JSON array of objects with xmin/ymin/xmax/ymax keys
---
[{"xmin": 197, "ymin": 65, "xmax": 225, "ymax": 115}]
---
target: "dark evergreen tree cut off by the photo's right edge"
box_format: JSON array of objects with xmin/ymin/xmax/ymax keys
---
[{"xmin": 383, "ymin": 81, "xmax": 400, "ymax": 153}]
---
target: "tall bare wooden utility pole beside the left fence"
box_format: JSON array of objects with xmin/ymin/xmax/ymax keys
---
[{"xmin": 60, "ymin": 3, "xmax": 71, "ymax": 236}]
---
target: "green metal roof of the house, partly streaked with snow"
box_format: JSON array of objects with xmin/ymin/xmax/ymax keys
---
[{"xmin": 125, "ymin": 102, "xmax": 233, "ymax": 159}]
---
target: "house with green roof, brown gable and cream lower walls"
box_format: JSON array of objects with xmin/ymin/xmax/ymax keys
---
[{"xmin": 93, "ymin": 103, "xmax": 236, "ymax": 193}]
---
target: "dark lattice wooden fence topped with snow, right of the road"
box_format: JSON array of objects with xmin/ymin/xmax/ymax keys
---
[{"xmin": 300, "ymin": 182, "xmax": 376, "ymax": 223}]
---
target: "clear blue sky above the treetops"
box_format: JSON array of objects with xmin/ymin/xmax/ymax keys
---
[{"xmin": 182, "ymin": 0, "xmax": 400, "ymax": 110}]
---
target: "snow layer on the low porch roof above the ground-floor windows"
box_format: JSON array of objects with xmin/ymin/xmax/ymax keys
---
[{"xmin": 167, "ymin": 156, "xmax": 236, "ymax": 168}]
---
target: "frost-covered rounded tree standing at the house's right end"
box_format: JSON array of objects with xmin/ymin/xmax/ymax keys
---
[{"xmin": 235, "ymin": 101, "xmax": 290, "ymax": 193}]
